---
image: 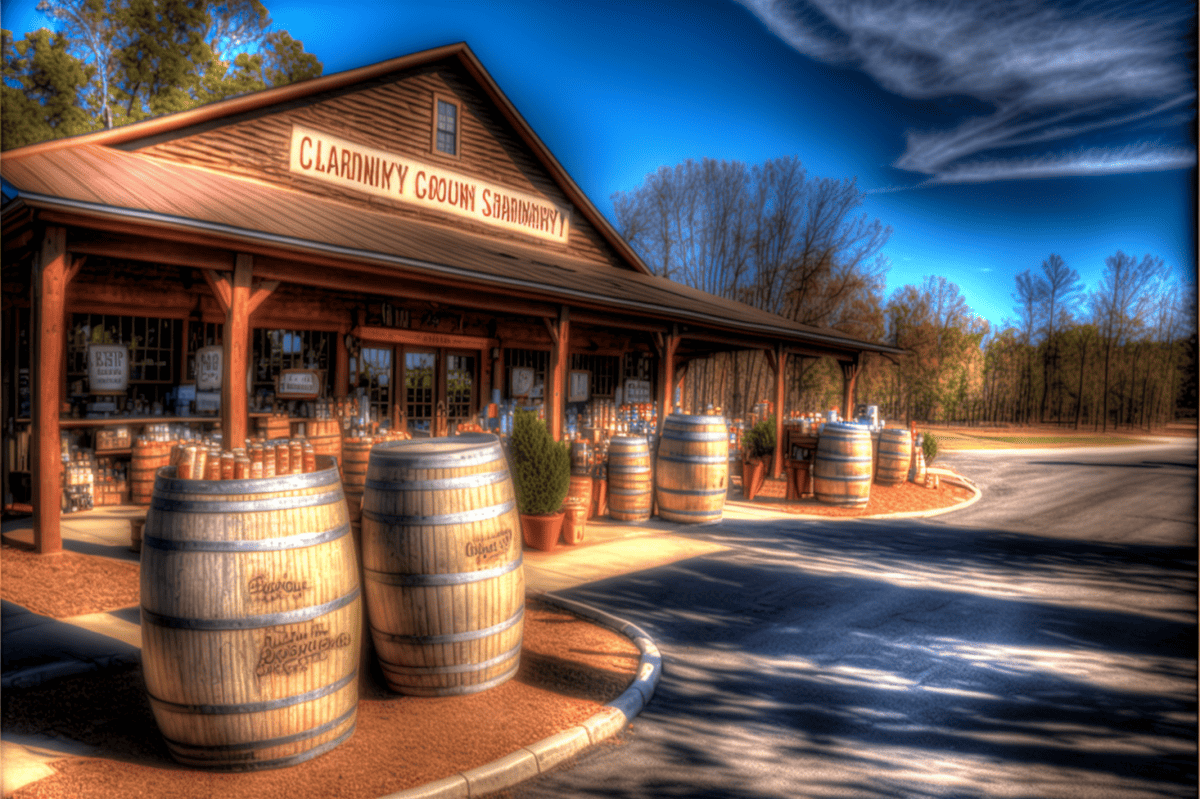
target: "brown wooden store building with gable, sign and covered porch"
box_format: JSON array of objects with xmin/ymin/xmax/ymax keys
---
[{"xmin": 0, "ymin": 44, "xmax": 898, "ymax": 552}]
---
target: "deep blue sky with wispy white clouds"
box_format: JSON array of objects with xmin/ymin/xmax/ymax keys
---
[{"xmin": 0, "ymin": 0, "xmax": 1196, "ymax": 325}]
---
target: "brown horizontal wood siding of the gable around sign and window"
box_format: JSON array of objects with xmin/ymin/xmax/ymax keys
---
[{"xmin": 131, "ymin": 62, "xmax": 630, "ymax": 269}]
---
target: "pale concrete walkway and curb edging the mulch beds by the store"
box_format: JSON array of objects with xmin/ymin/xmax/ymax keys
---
[{"xmin": 0, "ymin": 469, "xmax": 979, "ymax": 799}]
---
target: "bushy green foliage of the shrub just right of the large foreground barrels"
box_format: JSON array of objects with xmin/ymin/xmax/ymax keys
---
[{"xmin": 510, "ymin": 409, "xmax": 571, "ymax": 515}]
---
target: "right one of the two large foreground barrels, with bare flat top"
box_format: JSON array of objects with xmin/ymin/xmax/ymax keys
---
[{"xmin": 362, "ymin": 433, "xmax": 524, "ymax": 696}]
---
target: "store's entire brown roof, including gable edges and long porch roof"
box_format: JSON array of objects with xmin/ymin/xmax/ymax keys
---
[{"xmin": 0, "ymin": 44, "xmax": 901, "ymax": 353}]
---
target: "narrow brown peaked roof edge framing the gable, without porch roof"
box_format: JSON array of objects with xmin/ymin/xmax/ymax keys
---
[{"xmin": 0, "ymin": 42, "xmax": 652, "ymax": 275}]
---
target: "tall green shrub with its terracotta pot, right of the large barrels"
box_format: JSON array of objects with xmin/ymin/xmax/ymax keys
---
[{"xmin": 510, "ymin": 409, "xmax": 571, "ymax": 552}]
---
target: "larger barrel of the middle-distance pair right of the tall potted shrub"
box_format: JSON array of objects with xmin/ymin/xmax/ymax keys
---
[{"xmin": 654, "ymin": 414, "xmax": 730, "ymax": 523}]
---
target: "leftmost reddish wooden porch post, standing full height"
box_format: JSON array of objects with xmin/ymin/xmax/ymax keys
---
[{"xmin": 30, "ymin": 227, "xmax": 72, "ymax": 554}]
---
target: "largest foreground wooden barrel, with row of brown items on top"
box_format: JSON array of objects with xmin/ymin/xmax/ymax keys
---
[{"xmin": 142, "ymin": 458, "xmax": 362, "ymax": 770}]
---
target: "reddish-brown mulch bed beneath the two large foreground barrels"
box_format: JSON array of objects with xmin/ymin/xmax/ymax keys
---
[{"xmin": 2, "ymin": 597, "xmax": 640, "ymax": 799}]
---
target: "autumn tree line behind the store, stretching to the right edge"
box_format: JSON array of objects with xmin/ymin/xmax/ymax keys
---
[{"xmin": 612, "ymin": 158, "xmax": 1196, "ymax": 429}]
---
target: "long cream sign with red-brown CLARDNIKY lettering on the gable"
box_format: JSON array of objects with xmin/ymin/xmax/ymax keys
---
[{"xmin": 288, "ymin": 125, "xmax": 571, "ymax": 244}]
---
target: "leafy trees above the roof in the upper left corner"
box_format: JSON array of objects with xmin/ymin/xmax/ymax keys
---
[{"xmin": 0, "ymin": 0, "xmax": 323, "ymax": 150}]
